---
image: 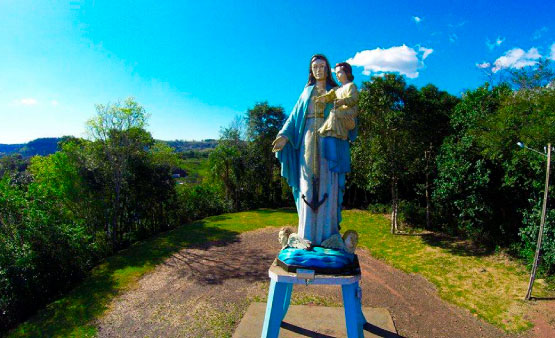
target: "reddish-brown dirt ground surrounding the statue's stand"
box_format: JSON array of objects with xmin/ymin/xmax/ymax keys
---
[{"xmin": 97, "ymin": 228, "xmax": 553, "ymax": 337}]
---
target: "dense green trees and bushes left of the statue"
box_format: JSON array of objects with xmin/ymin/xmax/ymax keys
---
[{"xmin": 0, "ymin": 99, "xmax": 230, "ymax": 330}]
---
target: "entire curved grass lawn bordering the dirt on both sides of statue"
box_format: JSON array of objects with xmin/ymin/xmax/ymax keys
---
[{"xmin": 10, "ymin": 209, "xmax": 553, "ymax": 337}]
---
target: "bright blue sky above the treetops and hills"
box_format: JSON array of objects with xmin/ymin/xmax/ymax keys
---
[{"xmin": 0, "ymin": 0, "xmax": 555, "ymax": 143}]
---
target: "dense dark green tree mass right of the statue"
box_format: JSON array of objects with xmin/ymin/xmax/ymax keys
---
[{"xmin": 345, "ymin": 61, "xmax": 555, "ymax": 275}]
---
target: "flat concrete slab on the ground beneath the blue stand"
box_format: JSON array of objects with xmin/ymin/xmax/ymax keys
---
[{"xmin": 233, "ymin": 303, "xmax": 398, "ymax": 338}]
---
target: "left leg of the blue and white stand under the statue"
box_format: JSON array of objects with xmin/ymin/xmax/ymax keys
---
[{"xmin": 261, "ymin": 279, "xmax": 289, "ymax": 338}]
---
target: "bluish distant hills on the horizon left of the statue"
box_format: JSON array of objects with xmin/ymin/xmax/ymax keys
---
[{"xmin": 0, "ymin": 137, "xmax": 218, "ymax": 157}]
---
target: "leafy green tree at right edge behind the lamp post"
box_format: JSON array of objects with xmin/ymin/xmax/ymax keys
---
[{"xmin": 478, "ymin": 87, "xmax": 555, "ymax": 271}]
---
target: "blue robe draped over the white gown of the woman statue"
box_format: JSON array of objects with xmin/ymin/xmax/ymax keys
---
[{"xmin": 276, "ymin": 85, "xmax": 357, "ymax": 235}]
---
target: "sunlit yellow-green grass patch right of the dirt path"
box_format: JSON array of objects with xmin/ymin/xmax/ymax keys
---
[{"xmin": 342, "ymin": 210, "xmax": 555, "ymax": 332}]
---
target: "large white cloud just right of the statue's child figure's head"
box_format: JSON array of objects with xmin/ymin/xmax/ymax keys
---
[{"xmin": 347, "ymin": 45, "xmax": 433, "ymax": 79}]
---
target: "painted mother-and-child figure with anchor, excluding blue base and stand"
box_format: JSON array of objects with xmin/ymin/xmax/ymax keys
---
[{"xmin": 273, "ymin": 54, "xmax": 358, "ymax": 270}]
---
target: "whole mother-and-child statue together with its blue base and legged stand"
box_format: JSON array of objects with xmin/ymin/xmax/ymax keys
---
[{"xmin": 262, "ymin": 54, "xmax": 366, "ymax": 337}]
